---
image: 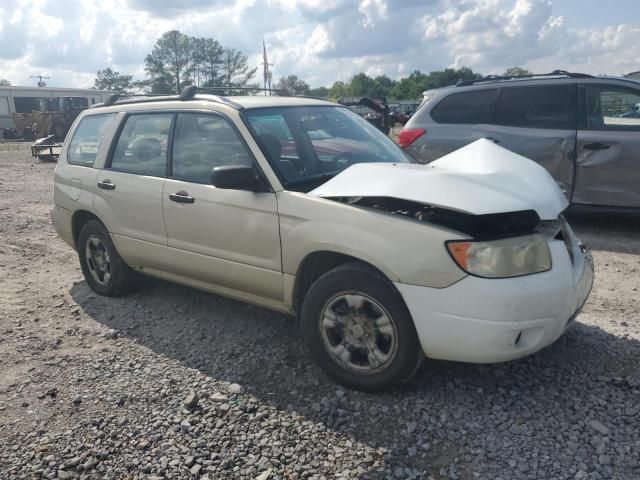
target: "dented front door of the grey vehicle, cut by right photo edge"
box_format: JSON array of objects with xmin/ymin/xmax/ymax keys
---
[{"xmin": 573, "ymin": 85, "xmax": 640, "ymax": 208}]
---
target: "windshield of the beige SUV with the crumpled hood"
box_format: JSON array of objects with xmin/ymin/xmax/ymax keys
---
[{"xmin": 245, "ymin": 106, "xmax": 411, "ymax": 192}]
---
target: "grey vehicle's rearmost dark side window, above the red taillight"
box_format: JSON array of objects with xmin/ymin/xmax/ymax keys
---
[{"xmin": 431, "ymin": 88, "xmax": 496, "ymax": 124}]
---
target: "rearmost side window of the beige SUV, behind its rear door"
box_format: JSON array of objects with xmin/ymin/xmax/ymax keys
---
[{"xmin": 67, "ymin": 113, "xmax": 116, "ymax": 167}]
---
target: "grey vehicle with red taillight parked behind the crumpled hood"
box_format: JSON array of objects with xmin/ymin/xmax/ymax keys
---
[{"xmin": 398, "ymin": 71, "xmax": 640, "ymax": 209}]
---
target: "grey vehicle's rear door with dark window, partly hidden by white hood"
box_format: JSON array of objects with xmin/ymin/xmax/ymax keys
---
[{"xmin": 485, "ymin": 84, "xmax": 577, "ymax": 198}]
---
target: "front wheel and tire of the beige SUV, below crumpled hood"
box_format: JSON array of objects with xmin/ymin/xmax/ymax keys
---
[{"xmin": 300, "ymin": 262, "xmax": 424, "ymax": 392}]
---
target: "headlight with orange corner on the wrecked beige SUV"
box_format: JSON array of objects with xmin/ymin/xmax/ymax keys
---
[{"xmin": 446, "ymin": 234, "xmax": 551, "ymax": 278}]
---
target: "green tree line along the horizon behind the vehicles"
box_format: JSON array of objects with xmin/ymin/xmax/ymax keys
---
[{"xmin": 94, "ymin": 30, "xmax": 530, "ymax": 99}]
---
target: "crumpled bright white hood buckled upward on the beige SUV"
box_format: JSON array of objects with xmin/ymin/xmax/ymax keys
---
[{"xmin": 309, "ymin": 139, "xmax": 569, "ymax": 220}]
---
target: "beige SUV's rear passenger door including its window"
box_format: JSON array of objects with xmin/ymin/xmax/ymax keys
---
[{"xmin": 94, "ymin": 113, "xmax": 174, "ymax": 267}]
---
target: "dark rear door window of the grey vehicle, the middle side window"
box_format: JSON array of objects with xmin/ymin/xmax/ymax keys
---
[{"xmin": 494, "ymin": 85, "xmax": 576, "ymax": 130}]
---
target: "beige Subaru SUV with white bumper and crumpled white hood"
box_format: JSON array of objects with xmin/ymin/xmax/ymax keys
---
[{"xmin": 51, "ymin": 87, "xmax": 593, "ymax": 390}]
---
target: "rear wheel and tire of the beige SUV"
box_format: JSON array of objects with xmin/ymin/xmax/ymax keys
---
[{"xmin": 77, "ymin": 220, "xmax": 137, "ymax": 297}]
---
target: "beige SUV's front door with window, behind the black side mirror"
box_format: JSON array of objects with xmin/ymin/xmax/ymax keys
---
[{"xmin": 162, "ymin": 113, "xmax": 283, "ymax": 301}]
